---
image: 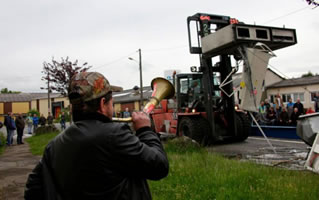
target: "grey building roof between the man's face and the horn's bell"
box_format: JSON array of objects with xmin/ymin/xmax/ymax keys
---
[{"xmin": 113, "ymin": 86, "xmax": 152, "ymax": 103}]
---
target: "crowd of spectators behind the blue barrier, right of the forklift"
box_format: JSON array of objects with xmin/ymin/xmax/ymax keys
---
[{"xmin": 258, "ymin": 93, "xmax": 319, "ymax": 126}]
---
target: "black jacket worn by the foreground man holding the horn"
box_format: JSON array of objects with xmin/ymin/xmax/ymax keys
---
[{"xmin": 25, "ymin": 113, "xmax": 168, "ymax": 200}]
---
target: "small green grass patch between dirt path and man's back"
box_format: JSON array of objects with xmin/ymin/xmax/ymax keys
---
[{"xmin": 25, "ymin": 132, "xmax": 59, "ymax": 155}]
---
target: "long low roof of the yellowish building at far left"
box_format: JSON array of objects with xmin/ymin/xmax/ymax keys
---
[{"xmin": 0, "ymin": 93, "xmax": 63, "ymax": 102}]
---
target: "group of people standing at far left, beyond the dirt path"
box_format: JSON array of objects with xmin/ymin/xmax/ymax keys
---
[{"xmin": 0, "ymin": 112, "xmax": 66, "ymax": 146}]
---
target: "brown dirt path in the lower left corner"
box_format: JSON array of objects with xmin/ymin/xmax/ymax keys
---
[{"xmin": 0, "ymin": 142, "xmax": 41, "ymax": 200}]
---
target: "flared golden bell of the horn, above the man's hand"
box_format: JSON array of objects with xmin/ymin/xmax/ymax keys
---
[{"xmin": 143, "ymin": 77, "xmax": 175, "ymax": 114}]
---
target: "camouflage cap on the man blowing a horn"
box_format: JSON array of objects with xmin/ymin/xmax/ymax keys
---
[{"xmin": 68, "ymin": 72, "xmax": 112, "ymax": 104}]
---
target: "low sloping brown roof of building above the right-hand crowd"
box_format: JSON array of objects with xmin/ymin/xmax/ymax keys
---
[{"xmin": 267, "ymin": 75, "xmax": 319, "ymax": 88}]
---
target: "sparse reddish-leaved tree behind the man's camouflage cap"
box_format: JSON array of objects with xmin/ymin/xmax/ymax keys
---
[{"xmin": 41, "ymin": 57, "xmax": 92, "ymax": 96}]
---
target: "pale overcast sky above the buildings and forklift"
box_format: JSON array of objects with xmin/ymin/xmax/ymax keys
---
[{"xmin": 0, "ymin": 0, "xmax": 319, "ymax": 92}]
